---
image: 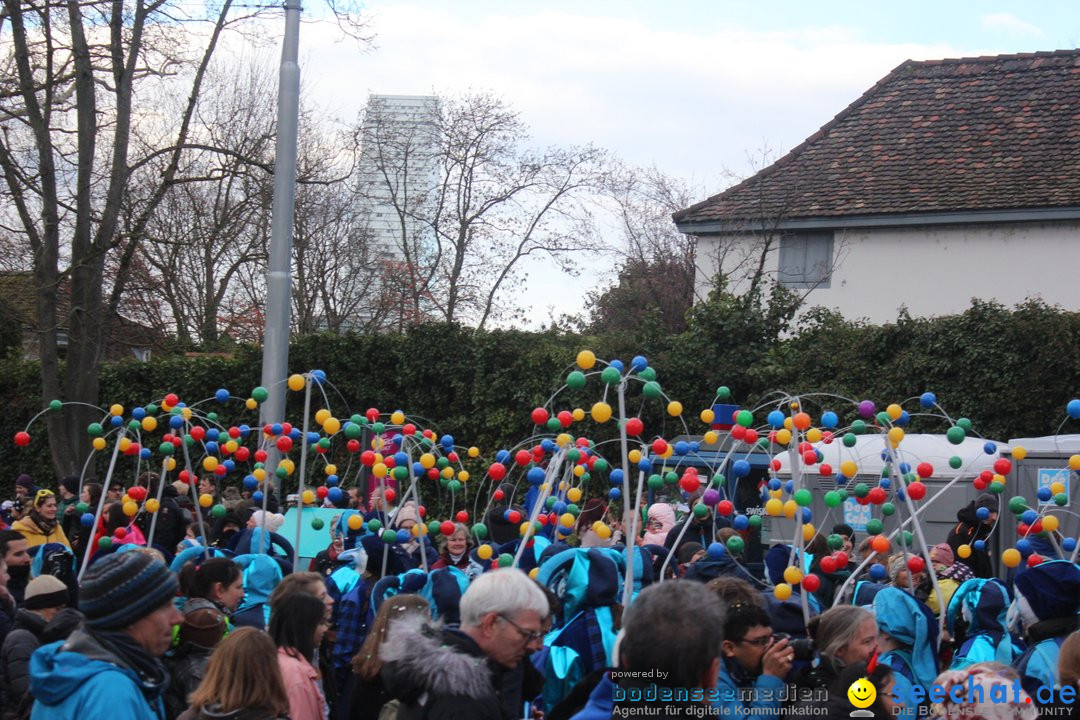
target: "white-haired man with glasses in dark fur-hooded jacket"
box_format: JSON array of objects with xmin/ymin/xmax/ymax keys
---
[{"xmin": 379, "ymin": 568, "xmax": 551, "ymax": 720}]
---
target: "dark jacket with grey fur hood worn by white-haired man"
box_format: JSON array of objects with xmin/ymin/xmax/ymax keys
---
[{"xmin": 379, "ymin": 617, "xmax": 515, "ymax": 720}]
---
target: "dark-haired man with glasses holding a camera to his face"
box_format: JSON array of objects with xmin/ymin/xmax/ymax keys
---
[{"xmin": 715, "ymin": 603, "xmax": 795, "ymax": 720}]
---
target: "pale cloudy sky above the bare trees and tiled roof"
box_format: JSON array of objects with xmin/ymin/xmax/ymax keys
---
[{"xmin": 285, "ymin": 0, "xmax": 1080, "ymax": 323}]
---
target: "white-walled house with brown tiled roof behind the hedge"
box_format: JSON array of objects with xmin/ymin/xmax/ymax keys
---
[{"xmin": 674, "ymin": 50, "xmax": 1080, "ymax": 323}]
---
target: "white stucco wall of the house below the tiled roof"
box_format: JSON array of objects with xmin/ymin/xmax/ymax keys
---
[{"xmin": 698, "ymin": 222, "xmax": 1080, "ymax": 323}]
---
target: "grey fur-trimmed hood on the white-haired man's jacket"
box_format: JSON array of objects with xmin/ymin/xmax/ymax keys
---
[{"xmin": 379, "ymin": 615, "xmax": 496, "ymax": 703}]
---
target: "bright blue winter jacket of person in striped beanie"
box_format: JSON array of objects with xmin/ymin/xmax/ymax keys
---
[{"xmin": 30, "ymin": 629, "xmax": 167, "ymax": 720}]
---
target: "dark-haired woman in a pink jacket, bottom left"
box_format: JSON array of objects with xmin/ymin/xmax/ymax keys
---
[{"xmin": 270, "ymin": 593, "xmax": 329, "ymax": 720}]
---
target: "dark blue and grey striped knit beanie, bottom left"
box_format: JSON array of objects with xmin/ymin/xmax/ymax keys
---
[{"xmin": 79, "ymin": 551, "xmax": 179, "ymax": 630}]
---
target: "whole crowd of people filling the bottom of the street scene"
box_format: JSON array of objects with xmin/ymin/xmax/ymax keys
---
[{"xmin": 0, "ymin": 474, "xmax": 1080, "ymax": 720}]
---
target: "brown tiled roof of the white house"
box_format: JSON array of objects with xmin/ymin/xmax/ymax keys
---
[{"xmin": 674, "ymin": 50, "xmax": 1080, "ymax": 225}]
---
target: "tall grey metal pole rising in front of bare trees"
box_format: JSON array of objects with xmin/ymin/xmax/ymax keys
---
[{"xmin": 255, "ymin": 0, "xmax": 300, "ymax": 488}]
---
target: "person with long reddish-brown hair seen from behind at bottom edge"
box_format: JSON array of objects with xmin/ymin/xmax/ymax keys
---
[{"xmin": 178, "ymin": 627, "xmax": 289, "ymax": 720}]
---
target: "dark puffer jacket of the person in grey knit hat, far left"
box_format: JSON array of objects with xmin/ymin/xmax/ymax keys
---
[{"xmin": 0, "ymin": 608, "xmax": 82, "ymax": 720}]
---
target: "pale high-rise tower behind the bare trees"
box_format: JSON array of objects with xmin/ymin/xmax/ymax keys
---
[{"xmin": 359, "ymin": 95, "xmax": 438, "ymax": 268}]
